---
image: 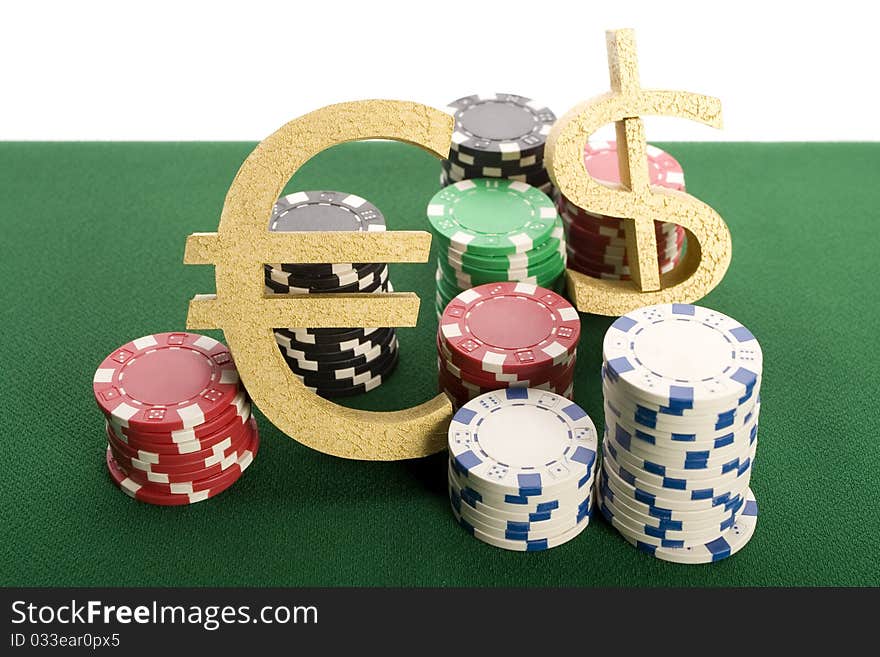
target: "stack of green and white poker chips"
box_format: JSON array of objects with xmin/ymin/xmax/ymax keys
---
[{"xmin": 427, "ymin": 178, "xmax": 566, "ymax": 315}]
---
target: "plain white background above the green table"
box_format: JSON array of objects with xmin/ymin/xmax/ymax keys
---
[{"xmin": 0, "ymin": 0, "xmax": 880, "ymax": 141}]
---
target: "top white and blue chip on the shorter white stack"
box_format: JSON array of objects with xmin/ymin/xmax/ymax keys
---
[{"xmin": 449, "ymin": 388, "xmax": 599, "ymax": 496}]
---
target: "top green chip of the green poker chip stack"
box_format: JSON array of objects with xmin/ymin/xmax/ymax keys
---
[{"xmin": 427, "ymin": 178, "xmax": 558, "ymax": 256}]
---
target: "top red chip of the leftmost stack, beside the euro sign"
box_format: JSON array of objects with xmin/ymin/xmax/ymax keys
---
[{"xmin": 93, "ymin": 333, "xmax": 239, "ymax": 433}]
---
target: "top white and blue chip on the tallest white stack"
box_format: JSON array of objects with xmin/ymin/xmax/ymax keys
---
[{"xmin": 602, "ymin": 303, "xmax": 763, "ymax": 413}]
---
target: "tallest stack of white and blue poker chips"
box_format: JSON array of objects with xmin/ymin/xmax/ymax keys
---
[{"xmin": 600, "ymin": 304, "xmax": 762, "ymax": 563}]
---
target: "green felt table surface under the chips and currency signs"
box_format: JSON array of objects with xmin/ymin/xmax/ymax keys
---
[{"xmin": 0, "ymin": 142, "xmax": 880, "ymax": 586}]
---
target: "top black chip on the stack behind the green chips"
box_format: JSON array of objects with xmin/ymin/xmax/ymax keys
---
[{"xmin": 448, "ymin": 94, "xmax": 556, "ymax": 160}]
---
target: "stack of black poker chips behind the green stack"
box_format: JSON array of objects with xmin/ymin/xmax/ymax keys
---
[{"xmin": 440, "ymin": 94, "xmax": 556, "ymax": 195}]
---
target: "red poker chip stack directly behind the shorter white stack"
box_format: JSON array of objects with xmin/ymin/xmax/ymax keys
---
[{"xmin": 437, "ymin": 283, "xmax": 581, "ymax": 408}]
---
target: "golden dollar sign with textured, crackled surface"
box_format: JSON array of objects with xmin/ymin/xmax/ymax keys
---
[{"xmin": 546, "ymin": 30, "xmax": 731, "ymax": 316}]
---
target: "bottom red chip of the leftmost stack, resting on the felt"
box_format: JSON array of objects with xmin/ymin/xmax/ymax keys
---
[{"xmin": 106, "ymin": 418, "xmax": 260, "ymax": 506}]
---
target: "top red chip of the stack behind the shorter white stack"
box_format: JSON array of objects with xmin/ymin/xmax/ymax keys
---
[{"xmin": 438, "ymin": 282, "xmax": 581, "ymax": 379}]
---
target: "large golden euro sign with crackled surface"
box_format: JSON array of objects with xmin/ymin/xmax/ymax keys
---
[{"xmin": 184, "ymin": 100, "xmax": 453, "ymax": 460}]
